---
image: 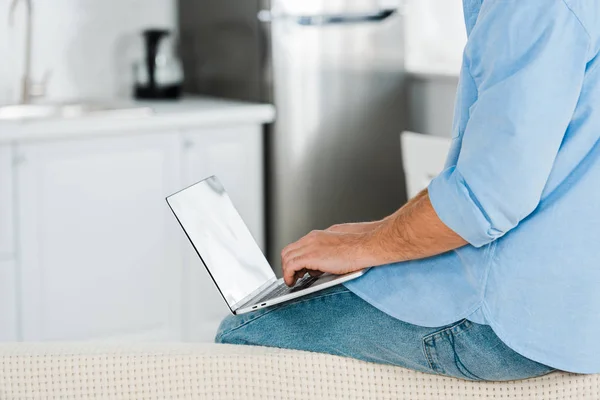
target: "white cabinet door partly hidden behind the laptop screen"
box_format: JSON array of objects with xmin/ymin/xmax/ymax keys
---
[{"xmin": 182, "ymin": 125, "xmax": 265, "ymax": 341}]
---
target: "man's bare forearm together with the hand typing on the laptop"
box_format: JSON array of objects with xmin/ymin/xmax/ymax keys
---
[{"xmin": 281, "ymin": 191, "xmax": 467, "ymax": 286}]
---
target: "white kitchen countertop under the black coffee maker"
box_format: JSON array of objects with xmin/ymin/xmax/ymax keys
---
[{"xmin": 0, "ymin": 97, "xmax": 275, "ymax": 143}]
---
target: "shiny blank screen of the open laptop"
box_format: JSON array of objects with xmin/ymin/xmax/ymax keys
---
[{"xmin": 167, "ymin": 176, "xmax": 275, "ymax": 310}]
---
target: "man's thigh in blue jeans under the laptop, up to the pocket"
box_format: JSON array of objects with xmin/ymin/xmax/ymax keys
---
[{"xmin": 216, "ymin": 285, "xmax": 435, "ymax": 372}]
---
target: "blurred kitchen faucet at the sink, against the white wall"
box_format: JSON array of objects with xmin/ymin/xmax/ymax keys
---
[{"xmin": 9, "ymin": 0, "xmax": 50, "ymax": 104}]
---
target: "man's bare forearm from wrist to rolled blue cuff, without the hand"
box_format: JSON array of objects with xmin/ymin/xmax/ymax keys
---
[{"xmin": 368, "ymin": 190, "xmax": 467, "ymax": 265}]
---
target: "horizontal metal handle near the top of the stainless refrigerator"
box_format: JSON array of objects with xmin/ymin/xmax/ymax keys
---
[{"xmin": 258, "ymin": 8, "xmax": 398, "ymax": 26}]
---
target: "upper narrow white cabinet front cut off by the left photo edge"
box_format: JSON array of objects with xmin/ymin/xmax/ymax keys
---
[{"xmin": 0, "ymin": 145, "xmax": 14, "ymax": 260}]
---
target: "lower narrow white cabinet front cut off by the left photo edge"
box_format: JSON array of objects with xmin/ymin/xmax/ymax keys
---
[{"xmin": 0, "ymin": 261, "xmax": 18, "ymax": 342}]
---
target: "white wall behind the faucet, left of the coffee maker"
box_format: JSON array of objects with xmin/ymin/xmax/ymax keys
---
[{"xmin": 0, "ymin": 0, "xmax": 176, "ymax": 103}]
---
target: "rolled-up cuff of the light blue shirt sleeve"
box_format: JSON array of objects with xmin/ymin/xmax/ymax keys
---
[{"xmin": 428, "ymin": 167, "xmax": 503, "ymax": 247}]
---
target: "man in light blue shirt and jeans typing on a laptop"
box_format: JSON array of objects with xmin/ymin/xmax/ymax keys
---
[{"xmin": 217, "ymin": 0, "xmax": 600, "ymax": 380}]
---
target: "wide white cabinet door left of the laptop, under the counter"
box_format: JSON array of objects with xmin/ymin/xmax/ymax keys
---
[{"xmin": 16, "ymin": 134, "xmax": 182, "ymax": 340}]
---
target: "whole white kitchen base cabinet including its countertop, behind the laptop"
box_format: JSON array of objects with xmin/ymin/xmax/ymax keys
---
[{"xmin": 0, "ymin": 98, "xmax": 274, "ymax": 341}]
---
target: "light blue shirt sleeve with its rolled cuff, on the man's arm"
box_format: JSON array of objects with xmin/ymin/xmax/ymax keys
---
[{"xmin": 429, "ymin": 0, "xmax": 591, "ymax": 247}]
